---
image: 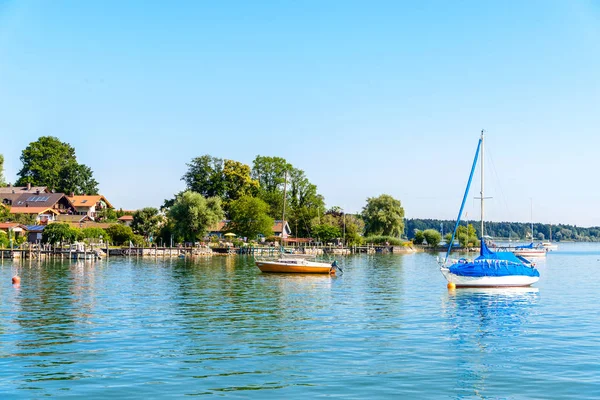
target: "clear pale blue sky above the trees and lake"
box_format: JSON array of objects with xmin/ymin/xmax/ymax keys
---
[{"xmin": 0, "ymin": 0, "xmax": 600, "ymax": 226}]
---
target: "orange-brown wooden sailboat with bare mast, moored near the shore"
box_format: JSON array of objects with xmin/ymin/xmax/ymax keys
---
[{"xmin": 255, "ymin": 171, "xmax": 341, "ymax": 275}]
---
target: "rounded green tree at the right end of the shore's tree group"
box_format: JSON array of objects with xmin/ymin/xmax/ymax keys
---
[{"xmin": 362, "ymin": 194, "xmax": 404, "ymax": 237}]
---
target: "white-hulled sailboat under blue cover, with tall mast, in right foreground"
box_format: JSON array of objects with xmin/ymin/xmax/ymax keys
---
[{"xmin": 440, "ymin": 130, "xmax": 540, "ymax": 287}]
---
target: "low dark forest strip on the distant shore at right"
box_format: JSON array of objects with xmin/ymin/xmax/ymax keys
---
[{"xmin": 404, "ymin": 218, "xmax": 600, "ymax": 242}]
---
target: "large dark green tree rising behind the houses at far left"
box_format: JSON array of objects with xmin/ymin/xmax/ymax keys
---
[{"xmin": 15, "ymin": 136, "xmax": 98, "ymax": 194}]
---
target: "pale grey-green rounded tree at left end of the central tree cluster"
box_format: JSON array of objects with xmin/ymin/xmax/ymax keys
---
[{"xmin": 168, "ymin": 191, "xmax": 224, "ymax": 242}]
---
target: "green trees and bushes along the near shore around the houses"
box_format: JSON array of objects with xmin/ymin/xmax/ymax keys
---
[{"xmin": 0, "ymin": 136, "xmax": 404, "ymax": 245}]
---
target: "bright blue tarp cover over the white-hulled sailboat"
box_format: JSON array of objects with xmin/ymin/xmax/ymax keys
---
[{"xmin": 449, "ymin": 240, "xmax": 540, "ymax": 277}]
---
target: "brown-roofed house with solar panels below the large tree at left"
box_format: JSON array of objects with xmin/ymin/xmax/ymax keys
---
[{"xmin": 10, "ymin": 190, "xmax": 74, "ymax": 224}]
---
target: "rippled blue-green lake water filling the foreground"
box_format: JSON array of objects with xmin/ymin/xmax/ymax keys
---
[{"xmin": 0, "ymin": 244, "xmax": 600, "ymax": 399}]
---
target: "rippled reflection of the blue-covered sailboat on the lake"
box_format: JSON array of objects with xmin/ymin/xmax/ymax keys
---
[{"xmin": 442, "ymin": 287, "xmax": 539, "ymax": 398}]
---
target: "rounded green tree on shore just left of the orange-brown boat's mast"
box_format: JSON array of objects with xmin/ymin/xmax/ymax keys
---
[{"xmin": 227, "ymin": 196, "xmax": 275, "ymax": 238}]
